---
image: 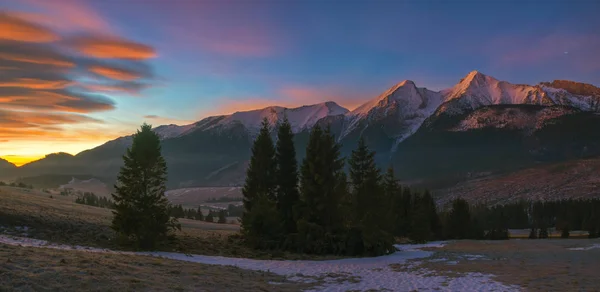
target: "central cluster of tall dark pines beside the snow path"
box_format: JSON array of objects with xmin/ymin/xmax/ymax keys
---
[{"xmin": 242, "ymin": 119, "xmax": 432, "ymax": 255}]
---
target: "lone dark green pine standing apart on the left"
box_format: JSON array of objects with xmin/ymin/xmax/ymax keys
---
[{"xmin": 111, "ymin": 124, "xmax": 179, "ymax": 248}]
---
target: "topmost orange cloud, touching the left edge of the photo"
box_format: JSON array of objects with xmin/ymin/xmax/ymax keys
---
[{"xmin": 0, "ymin": 11, "xmax": 59, "ymax": 43}]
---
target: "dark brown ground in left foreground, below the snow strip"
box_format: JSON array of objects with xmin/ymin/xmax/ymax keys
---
[{"xmin": 0, "ymin": 244, "xmax": 314, "ymax": 291}]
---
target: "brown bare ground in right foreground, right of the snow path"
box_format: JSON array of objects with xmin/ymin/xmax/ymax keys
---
[{"xmin": 414, "ymin": 239, "xmax": 600, "ymax": 291}]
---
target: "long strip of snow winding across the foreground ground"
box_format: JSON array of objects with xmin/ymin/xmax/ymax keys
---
[{"xmin": 0, "ymin": 235, "xmax": 519, "ymax": 291}]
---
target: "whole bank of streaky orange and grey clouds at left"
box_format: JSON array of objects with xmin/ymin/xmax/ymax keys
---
[{"xmin": 0, "ymin": 7, "xmax": 156, "ymax": 162}]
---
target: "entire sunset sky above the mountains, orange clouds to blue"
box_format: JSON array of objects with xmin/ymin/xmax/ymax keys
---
[{"xmin": 0, "ymin": 0, "xmax": 600, "ymax": 165}]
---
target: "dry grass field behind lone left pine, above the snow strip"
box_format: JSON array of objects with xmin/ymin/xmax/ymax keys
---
[{"xmin": 0, "ymin": 187, "xmax": 336, "ymax": 259}]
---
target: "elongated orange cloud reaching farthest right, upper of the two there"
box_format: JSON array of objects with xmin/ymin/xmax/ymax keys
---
[{"xmin": 68, "ymin": 35, "xmax": 157, "ymax": 60}]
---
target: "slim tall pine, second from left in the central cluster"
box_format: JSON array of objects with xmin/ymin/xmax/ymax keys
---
[{"xmin": 275, "ymin": 117, "xmax": 300, "ymax": 234}]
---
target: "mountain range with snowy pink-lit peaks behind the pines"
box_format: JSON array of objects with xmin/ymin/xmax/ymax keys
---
[{"xmin": 0, "ymin": 71, "xmax": 600, "ymax": 196}]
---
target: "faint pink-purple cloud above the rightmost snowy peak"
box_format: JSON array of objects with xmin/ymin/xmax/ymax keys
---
[{"xmin": 483, "ymin": 34, "xmax": 600, "ymax": 72}]
